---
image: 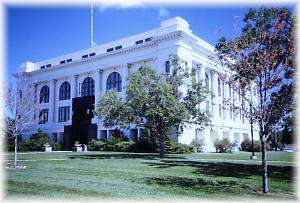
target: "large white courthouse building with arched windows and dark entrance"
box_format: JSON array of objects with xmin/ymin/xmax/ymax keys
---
[{"xmin": 19, "ymin": 17, "xmax": 258, "ymax": 151}]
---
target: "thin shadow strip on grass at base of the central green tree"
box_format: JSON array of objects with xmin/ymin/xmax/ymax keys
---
[{"xmin": 69, "ymin": 153, "xmax": 185, "ymax": 160}]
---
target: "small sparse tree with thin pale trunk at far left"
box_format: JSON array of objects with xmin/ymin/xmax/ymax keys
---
[{"xmin": 4, "ymin": 72, "xmax": 38, "ymax": 169}]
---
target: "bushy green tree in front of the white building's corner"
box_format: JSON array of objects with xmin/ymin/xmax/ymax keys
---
[{"xmin": 95, "ymin": 55, "xmax": 208, "ymax": 157}]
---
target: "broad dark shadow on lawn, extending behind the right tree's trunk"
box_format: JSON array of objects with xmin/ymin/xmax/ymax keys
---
[{"xmin": 147, "ymin": 160, "xmax": 294, "ymax": 182}]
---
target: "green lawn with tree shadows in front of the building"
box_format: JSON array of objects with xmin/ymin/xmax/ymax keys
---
[{"xmin": 6, "ymin": 152, "xmax": 296, "ymax": 200}]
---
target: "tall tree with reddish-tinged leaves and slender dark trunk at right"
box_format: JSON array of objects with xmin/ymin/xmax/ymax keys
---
[{"xmin": 216, "ymin": 8, "xmax": 295, "ymax": 193}]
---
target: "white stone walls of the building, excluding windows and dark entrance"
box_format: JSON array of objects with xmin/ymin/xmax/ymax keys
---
[{"xmin": 20, "ymin": 17, "xmax": 259, "ymax": 151}]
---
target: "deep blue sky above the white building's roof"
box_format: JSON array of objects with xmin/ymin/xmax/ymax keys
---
[{"xmin": 6, "ymin": 6, "xmax": 296, "ymax": 78}]
